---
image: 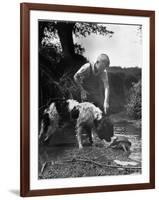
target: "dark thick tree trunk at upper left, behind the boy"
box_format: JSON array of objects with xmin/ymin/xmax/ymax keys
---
[{"xmin": 56, "ymin": 22, "xmax": 75, "ymax": 58}]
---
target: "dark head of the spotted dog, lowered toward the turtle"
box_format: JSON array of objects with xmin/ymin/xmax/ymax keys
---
[{"xmin": 97, "ymin": 116, "xmax": 114, "ymax": 142}]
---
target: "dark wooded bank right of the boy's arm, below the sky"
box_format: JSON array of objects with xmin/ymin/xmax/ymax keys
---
[{"xmin": 108, "ymin": 66, "xmax": 141, "ymax": 113}]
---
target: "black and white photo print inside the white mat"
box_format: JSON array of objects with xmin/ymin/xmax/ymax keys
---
[{"xmin": 38, "ymin": 19, "xmax": 143, "ymax": 179}]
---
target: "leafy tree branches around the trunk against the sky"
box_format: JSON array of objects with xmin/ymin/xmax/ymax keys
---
[{"xmin": 39, "ymin": 21, "xmax": 114, "ymax": 55}]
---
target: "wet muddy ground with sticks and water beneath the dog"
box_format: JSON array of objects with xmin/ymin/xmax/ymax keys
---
[{"xmin": 39, "ymin": 111, "xmax": 142, "ymax": 179}]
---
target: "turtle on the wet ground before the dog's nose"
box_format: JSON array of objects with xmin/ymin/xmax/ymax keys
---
[{"xmin": 109, "ymin": 136, "xmax": 131, "ymax": 152}]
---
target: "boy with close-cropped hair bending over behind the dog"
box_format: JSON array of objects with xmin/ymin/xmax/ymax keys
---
[{"xmin": 74, "ymin": 54, "xmax": 110, "ymax": 114}]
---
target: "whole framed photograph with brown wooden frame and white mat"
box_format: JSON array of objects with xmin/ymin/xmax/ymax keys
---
[{"xmin": 20, "ymin": 3, "xmax": 155, "ymax": 197}]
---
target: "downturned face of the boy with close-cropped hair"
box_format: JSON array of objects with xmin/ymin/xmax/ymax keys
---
[{"xmin": 94, "ymin": 56, "xmax": 109, "ymax": 75}]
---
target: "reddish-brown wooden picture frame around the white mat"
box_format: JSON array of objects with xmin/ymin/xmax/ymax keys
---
[{"xmin": 20, "ymin": 3, "xmax": 155, "ymax": 197}]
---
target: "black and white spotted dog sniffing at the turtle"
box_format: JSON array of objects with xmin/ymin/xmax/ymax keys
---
[{"xmin": 39, "ymin": 99, "xmax": 113, "ymax": 149}]
